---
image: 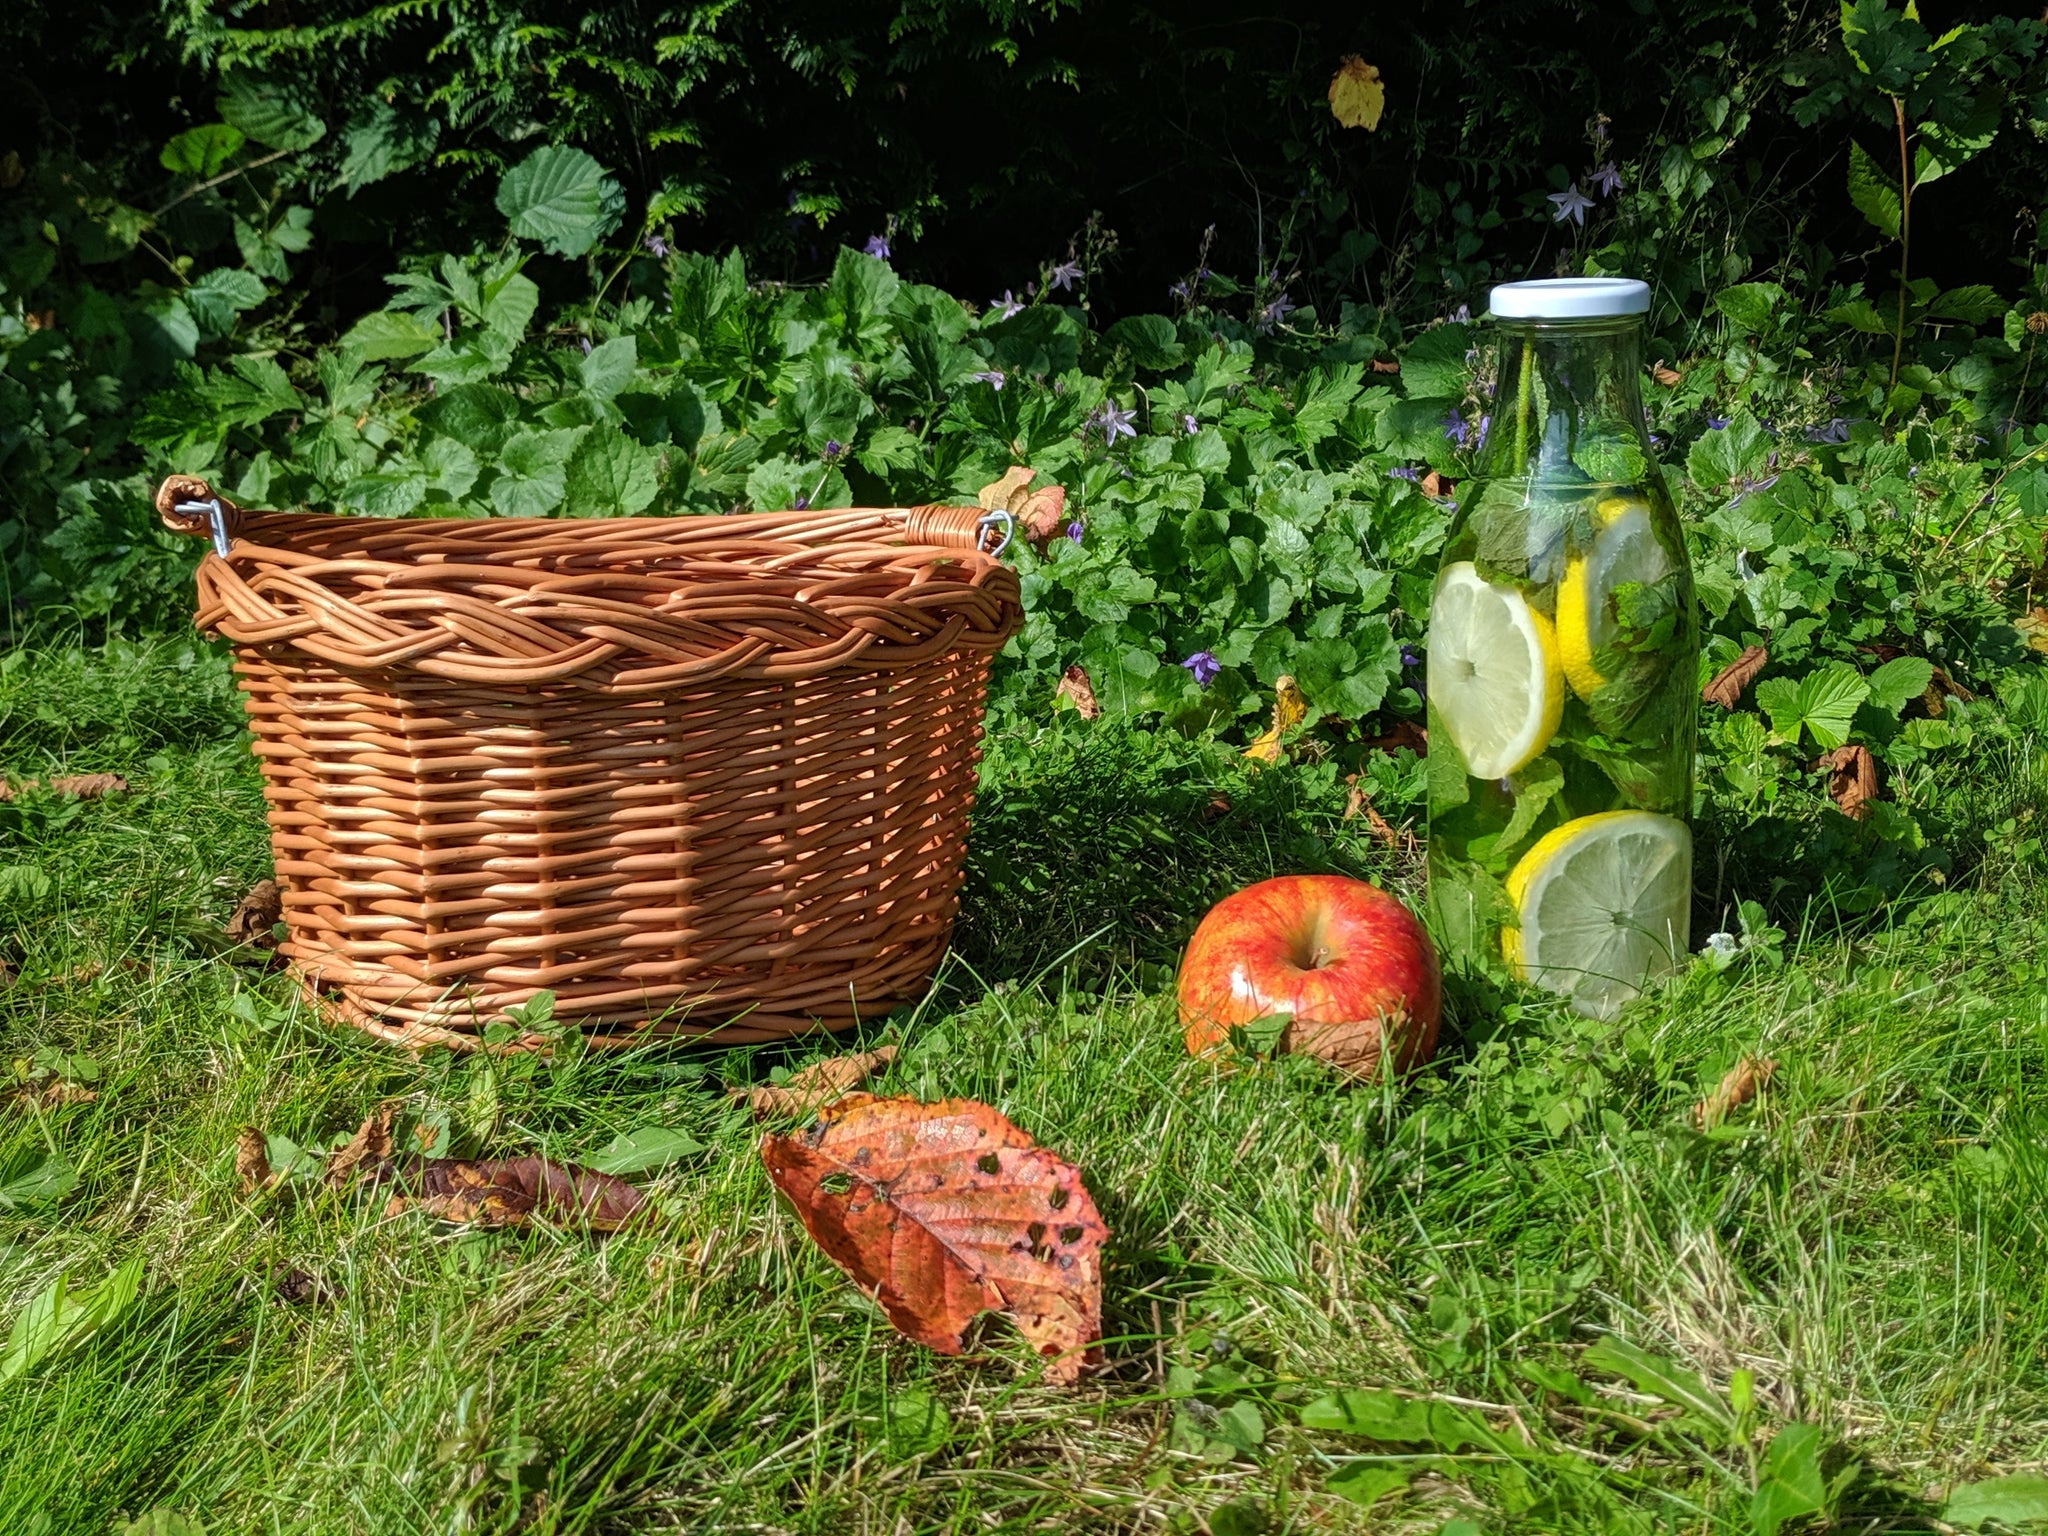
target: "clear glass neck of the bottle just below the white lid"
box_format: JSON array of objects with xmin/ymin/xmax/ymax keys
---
[{"xmin": 1479, "ymin": 317, "xmax": 1651, "ymax": 481}]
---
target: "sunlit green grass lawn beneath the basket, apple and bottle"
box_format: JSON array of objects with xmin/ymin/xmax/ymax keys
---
[{"xmin": 0, "ymin": 645, "xmax": 2048, "ymax": 1536}]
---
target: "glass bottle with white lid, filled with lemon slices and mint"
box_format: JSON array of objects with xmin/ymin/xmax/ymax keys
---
[{"xmin": 1425, "ymin": 279, "xmax": 1700, "ymax": 1018}]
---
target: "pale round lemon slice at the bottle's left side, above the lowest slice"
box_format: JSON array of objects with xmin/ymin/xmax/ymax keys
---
[{"xmin": 1430, "ymin": 559, "xmax": 1565, "ymax": 778}]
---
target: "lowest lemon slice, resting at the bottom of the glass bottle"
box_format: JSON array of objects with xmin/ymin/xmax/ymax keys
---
[{"xmin": 1501, "ymin": 811, "xmax": 1692, "ymax": 1018}]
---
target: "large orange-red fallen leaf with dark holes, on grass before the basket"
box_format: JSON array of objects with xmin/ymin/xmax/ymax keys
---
[{"xmin": 762, "ymin": 1098, "xmax": 1110, "ymax": 1382}]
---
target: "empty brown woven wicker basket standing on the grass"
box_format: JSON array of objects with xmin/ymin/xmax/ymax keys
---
[{"xmin": 158, "ymin": 475, "xmax": 1022, "ymax": 1049}]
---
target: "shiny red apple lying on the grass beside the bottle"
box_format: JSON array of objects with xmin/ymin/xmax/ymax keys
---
[{"xmin": 1180, "ymin": 874, "xmax": 1444, "ymax": 1077}]
